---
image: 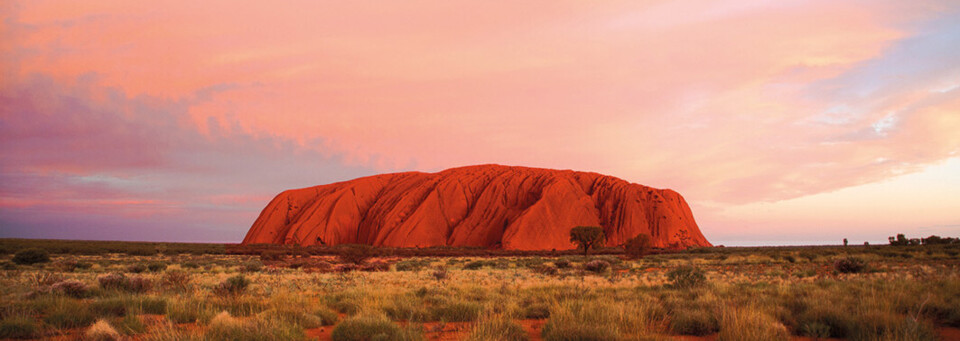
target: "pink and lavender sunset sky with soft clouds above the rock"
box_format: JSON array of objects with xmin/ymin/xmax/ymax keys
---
[{"xmin": 0, "ymin": 0, "xmax": 960, "ymax": 245}]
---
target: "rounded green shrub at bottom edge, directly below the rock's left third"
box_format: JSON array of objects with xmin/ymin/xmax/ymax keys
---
[{"xmin": 330, "ymin": 315, "xmax": 423, "ymax": 341}]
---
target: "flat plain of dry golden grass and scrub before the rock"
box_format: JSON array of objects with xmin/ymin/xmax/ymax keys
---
[{"xmin": 0, "ymin": 238, "xmax": 960, "ymax": 340}]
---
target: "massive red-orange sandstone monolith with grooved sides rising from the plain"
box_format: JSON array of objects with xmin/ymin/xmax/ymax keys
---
[{"xmin": 243, "ymin": 165, "xmax": 710, "ymax": 250}]
